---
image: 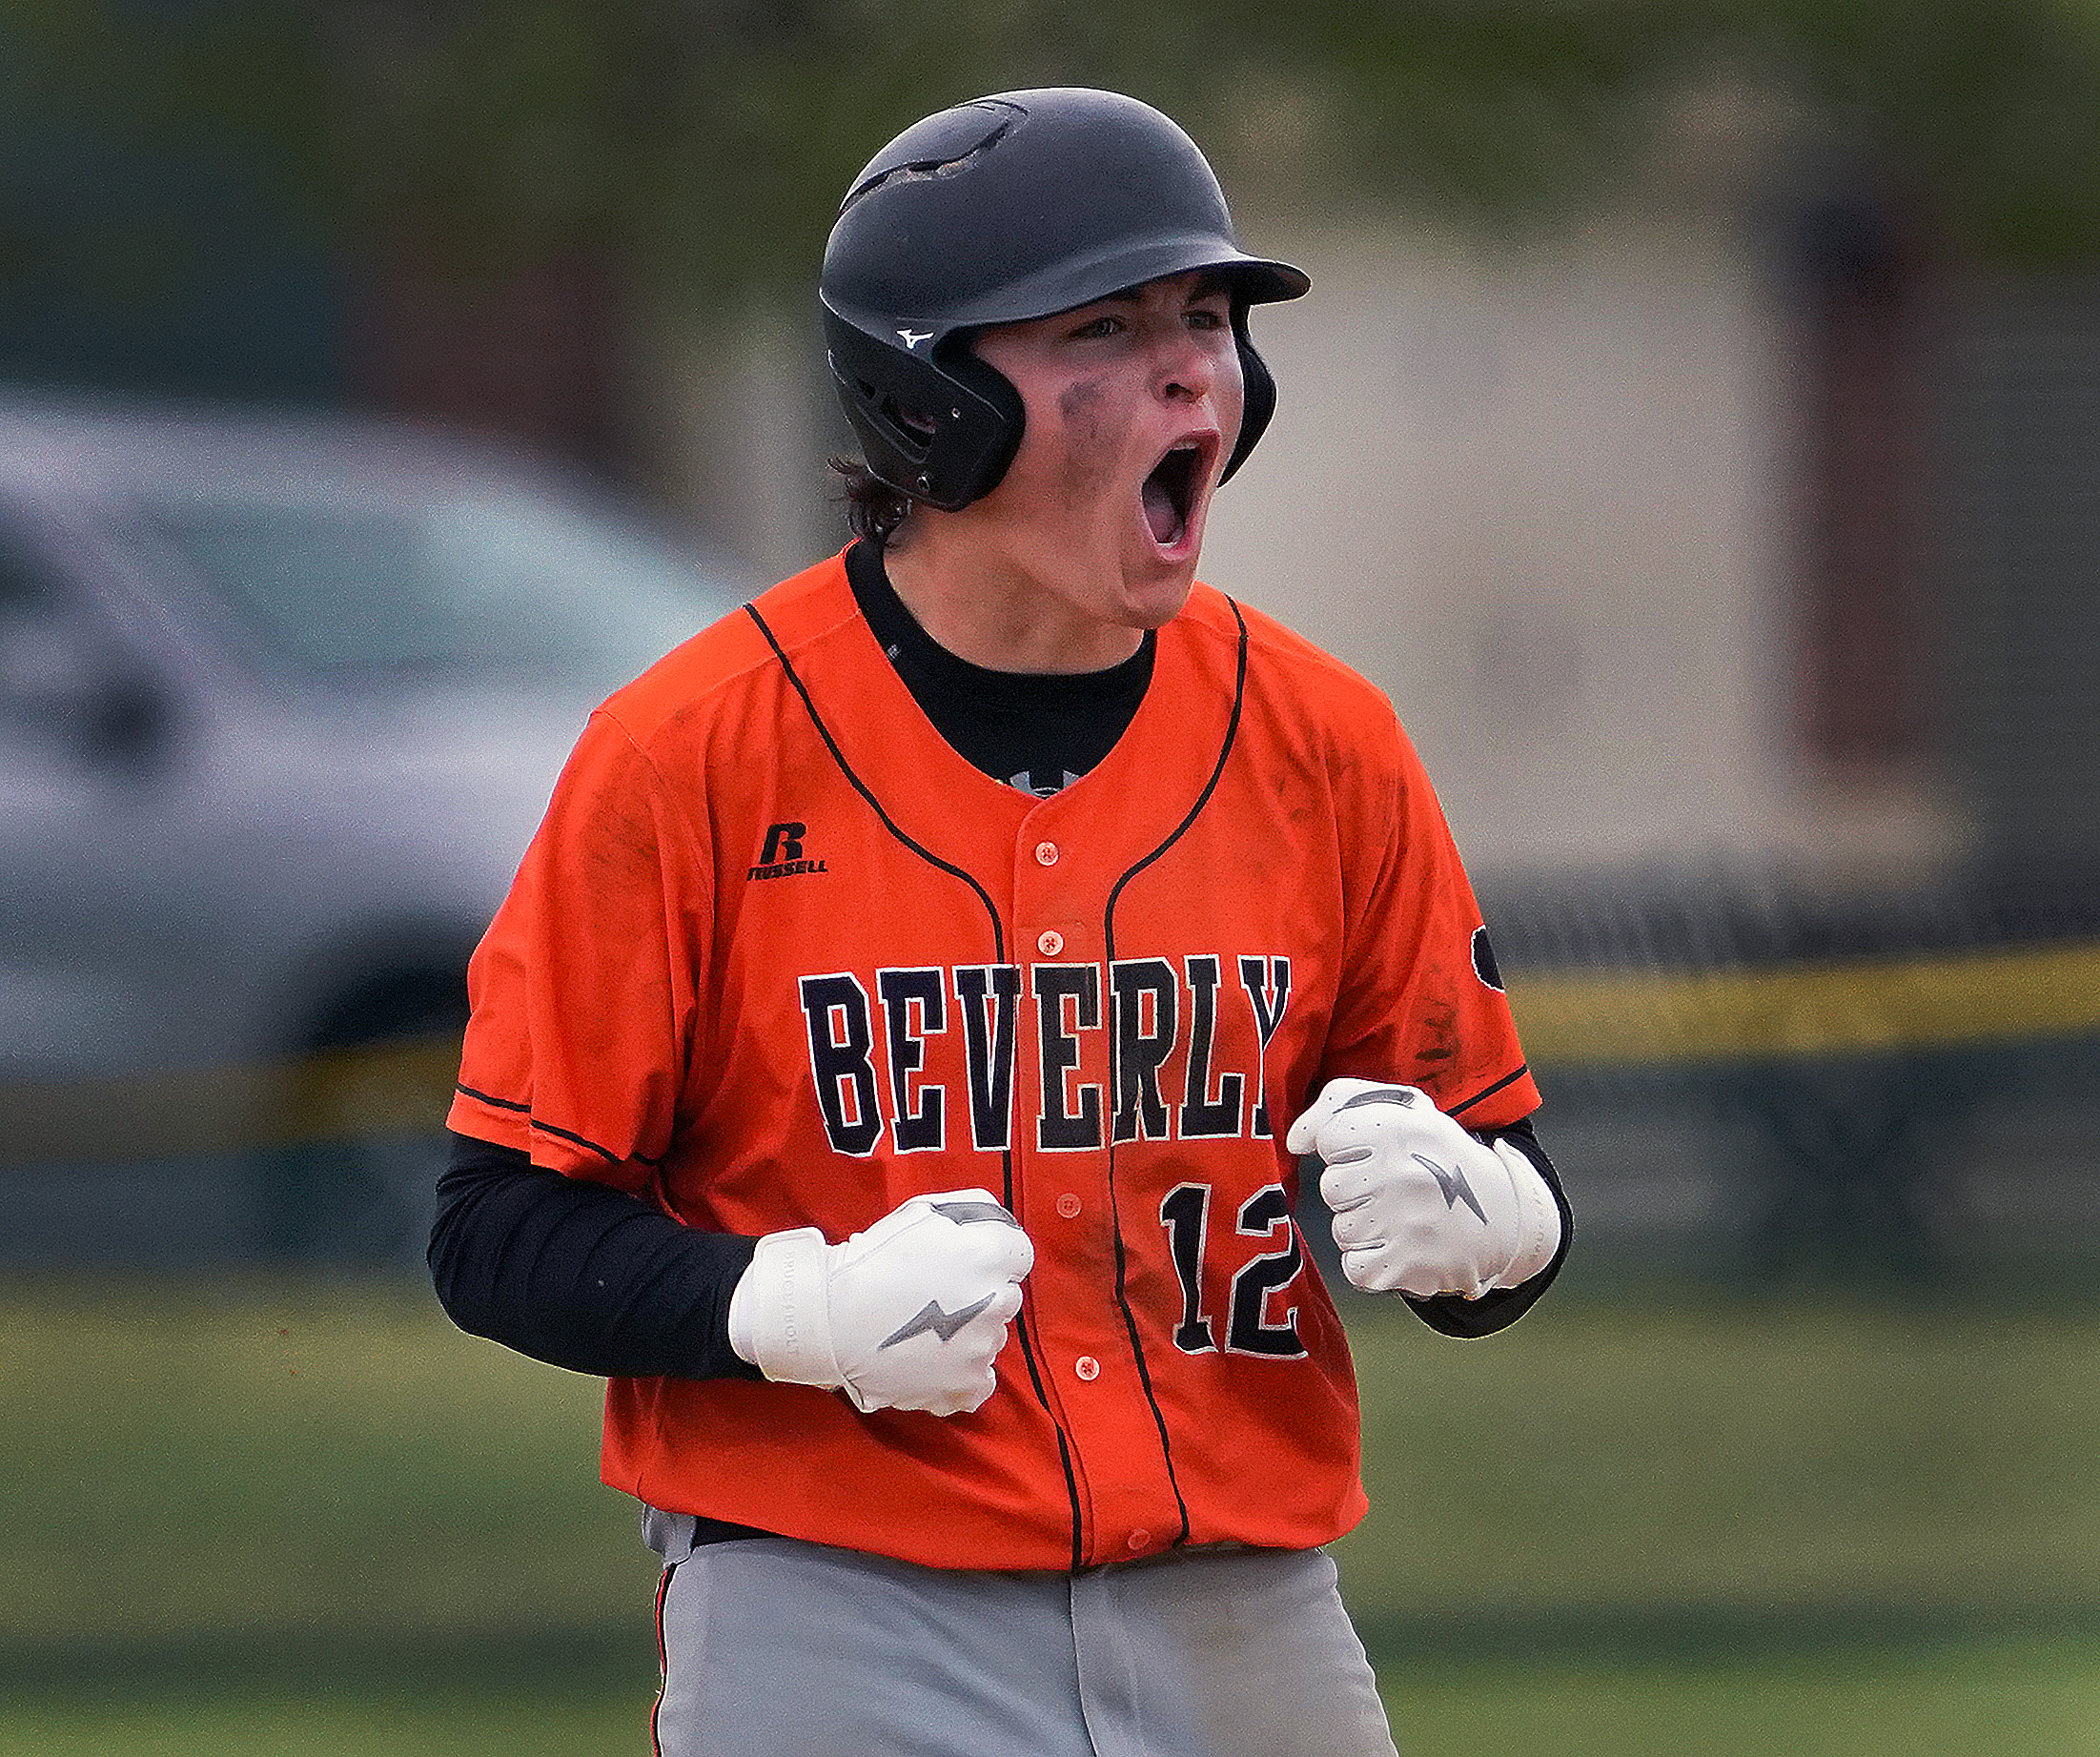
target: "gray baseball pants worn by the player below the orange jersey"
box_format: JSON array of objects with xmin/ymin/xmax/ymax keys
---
[{"xmin": 644, "ymin": 1514, "xmax": 1397, "ymax": 1757}]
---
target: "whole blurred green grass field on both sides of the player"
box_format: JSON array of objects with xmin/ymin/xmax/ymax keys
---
[{"xmin": 0, "ymin": 1282, "xmax": 2100, "ymax": 1757}]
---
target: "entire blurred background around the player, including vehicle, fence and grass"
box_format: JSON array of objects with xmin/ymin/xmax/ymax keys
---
[{"xmin": 0, "ymin": 0, "xmax": 2100, "ymax": 1753}]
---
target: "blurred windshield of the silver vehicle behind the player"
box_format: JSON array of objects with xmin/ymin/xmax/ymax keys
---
[{"xmin": 133, "ymin": 493, "xmax": 735, "ymax": 686}]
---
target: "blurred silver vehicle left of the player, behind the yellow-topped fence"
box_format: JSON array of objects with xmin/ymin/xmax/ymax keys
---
[{"xmin": 0, "ymin": 397, "xmax": 744, "ymax": 1264}]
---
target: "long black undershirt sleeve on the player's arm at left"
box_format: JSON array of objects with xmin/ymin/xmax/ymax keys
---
[{"xmin": 431, "ymin": 1134, "xmax": 763, "ymax": 1379}]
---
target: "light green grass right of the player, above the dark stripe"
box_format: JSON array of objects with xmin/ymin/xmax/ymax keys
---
[{"xmin": 1340, "ymin": 1301, "xmax": 2100, "ymax": 1633}]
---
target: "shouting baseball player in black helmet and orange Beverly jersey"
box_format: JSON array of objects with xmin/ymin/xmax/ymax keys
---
[{"xmin": 431, "ymin": 91, "xmax": 1569, "ymax": 1757}]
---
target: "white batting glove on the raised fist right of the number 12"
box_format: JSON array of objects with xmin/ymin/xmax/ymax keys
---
[{"xmin": 1283, "ymin": 1079, "xmax": 1560, "ymax": 1299}]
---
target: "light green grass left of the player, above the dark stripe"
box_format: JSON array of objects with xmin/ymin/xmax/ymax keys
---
[{"xmin": 0, "ymin": 1285, "xmax": 653, "ymax": 1656}]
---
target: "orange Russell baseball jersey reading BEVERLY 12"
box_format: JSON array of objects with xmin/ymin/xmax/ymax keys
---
[{"xmin": 449, "ymin": 557, "xmax": 1539, "ymax": 1568}]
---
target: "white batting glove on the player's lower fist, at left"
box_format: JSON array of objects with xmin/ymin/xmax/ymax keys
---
[{"xmin": 728, "ymin": 1190, "xmax": 1035, "ymax": 1415}]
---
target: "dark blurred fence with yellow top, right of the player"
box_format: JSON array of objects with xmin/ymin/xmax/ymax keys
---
[{"xmin": 1489, "ymin": 871, "xmax": 2100, "ymax": 1285}]
